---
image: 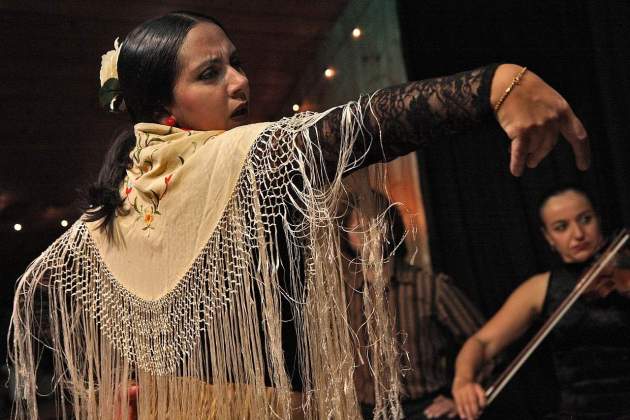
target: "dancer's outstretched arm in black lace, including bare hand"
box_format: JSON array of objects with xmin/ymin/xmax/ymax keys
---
[{"xmin": 318, "ymin": 64, "xmax": 589, "ymax": 176}]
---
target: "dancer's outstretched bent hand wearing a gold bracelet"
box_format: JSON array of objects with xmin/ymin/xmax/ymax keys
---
[{"xmin": 490, "ymin": 64, "xmax": 590, "ymax": 176}]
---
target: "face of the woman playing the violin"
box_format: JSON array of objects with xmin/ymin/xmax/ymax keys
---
[{"xmin": 541, "ymin": 190, "xmax": 603, "ymax": 263}]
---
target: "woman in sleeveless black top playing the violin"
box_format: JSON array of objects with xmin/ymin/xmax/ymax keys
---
[{"xmin": 452, "ymin": 186, "xmax": 630, "ymax": 419}]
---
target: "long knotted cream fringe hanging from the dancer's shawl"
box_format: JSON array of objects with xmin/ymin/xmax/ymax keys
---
[{"xmin": 9, "ymin": 99, "xmax": 401, "ymax": 419}]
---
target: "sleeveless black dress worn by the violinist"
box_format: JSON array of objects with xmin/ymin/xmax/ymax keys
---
[{"xmin": 543, "ymin": 264, "xmax": 630, "ymax": 419}]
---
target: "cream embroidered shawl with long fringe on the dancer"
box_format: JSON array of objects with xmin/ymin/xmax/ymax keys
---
[{"xmin": 10, "ymin": 103, "xmax": 400, "ymax": 419}]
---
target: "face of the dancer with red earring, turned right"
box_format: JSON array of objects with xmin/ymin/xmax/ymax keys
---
[{"xmin": 167, "ymin": 22, "xmax": 249, "ymax": 130}]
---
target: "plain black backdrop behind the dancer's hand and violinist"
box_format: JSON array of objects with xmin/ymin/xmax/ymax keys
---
[{"xmin": 398, "ymin": 0, "xmax": 630, "ymax": 419}]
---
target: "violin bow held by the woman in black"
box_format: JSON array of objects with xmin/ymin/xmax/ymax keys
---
[{"xmin": 486, "ymin": 229, "xmax": 630, "ymax": 405}]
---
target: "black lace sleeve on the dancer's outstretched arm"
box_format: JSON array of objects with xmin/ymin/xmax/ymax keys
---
[{"xmin": 317, "ymin": 65, "xmax": 498, "ymax": 175}]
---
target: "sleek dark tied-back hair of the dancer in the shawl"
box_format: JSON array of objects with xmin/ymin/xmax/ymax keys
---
[{"xmin": 85, "ymin": 11, "xmax": 227, "ymax": 237}]
